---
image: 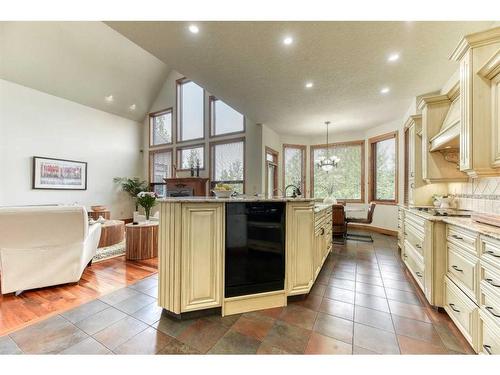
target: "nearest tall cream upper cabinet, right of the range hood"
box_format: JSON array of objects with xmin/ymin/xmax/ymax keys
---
[{"xmin": 451, "ymin": 27, "xmax": 500, "ymax": 178}]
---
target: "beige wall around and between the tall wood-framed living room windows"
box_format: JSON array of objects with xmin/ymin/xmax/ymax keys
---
[{"xmin": 142, "ymin": 70, "xmax": 262, "ymax": 194}]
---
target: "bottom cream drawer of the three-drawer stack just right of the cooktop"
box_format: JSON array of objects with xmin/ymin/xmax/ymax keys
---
[{"xmin": 444, "ymin": 277, "xmax": 478, "ymax": 348}]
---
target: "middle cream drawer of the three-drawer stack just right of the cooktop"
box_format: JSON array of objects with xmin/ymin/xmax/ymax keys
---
[{"xmin": 447, "ymin": 243, "xmax": 479, "ymax": 301}]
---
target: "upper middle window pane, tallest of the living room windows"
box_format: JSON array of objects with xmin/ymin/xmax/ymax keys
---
[{"xmin": 177, "ymin": 79, "xmax": 205, "ymax": 142}]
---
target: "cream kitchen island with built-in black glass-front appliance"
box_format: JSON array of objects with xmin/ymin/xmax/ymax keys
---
[{"xmin": 158, "ymin": 197, "xmax": 332, "ymax": 318}]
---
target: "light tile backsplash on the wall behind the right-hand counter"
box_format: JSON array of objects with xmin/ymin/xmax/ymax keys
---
[{"xmin": 448, "ymin": 177, "xmax": 500, "ymax": 215}]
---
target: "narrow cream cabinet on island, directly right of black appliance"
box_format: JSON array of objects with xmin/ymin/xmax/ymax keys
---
[{"xmin": 286, "ymin": 202, "xmax": 316, "ymax": 295}]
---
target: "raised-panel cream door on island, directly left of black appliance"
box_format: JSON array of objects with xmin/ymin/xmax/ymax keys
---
[{"xmin": 181, "ymin": 203, "xmax": 224, "ymax": 312}]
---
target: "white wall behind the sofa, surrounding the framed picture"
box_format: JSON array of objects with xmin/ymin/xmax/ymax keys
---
[{"xmin": 0, "ymin": 80, "xmax": 142, "ymax": 218}]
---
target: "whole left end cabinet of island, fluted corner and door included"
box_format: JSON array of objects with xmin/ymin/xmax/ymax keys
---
[{"xmin": 158, "ymin": 202, "xmax": 225, "ymax": 315}]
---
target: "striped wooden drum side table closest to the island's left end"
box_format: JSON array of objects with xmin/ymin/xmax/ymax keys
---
[{"xmin": 125, "ymin": 223, "xmax": 158, "ymax": 260}]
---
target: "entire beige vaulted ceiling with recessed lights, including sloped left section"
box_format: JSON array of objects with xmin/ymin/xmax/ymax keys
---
[{"xmin": 0, "ymin": 21, "xmax": 492, "ymax": 135}]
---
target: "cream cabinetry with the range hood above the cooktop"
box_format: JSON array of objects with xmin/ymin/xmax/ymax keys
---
[{"xmin": 418, "ymin": 84, "xmax": 468, "ymax": 183}]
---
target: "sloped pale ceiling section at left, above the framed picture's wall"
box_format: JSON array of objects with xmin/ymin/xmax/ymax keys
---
[{"xmin": 0, "ymin": 22, "xmax": 168, "ymax": 121}]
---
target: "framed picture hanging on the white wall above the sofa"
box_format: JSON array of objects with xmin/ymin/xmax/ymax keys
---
[{"xmin": 33, "ymin": 156, "xmax": 87, "ymax": 190}]
